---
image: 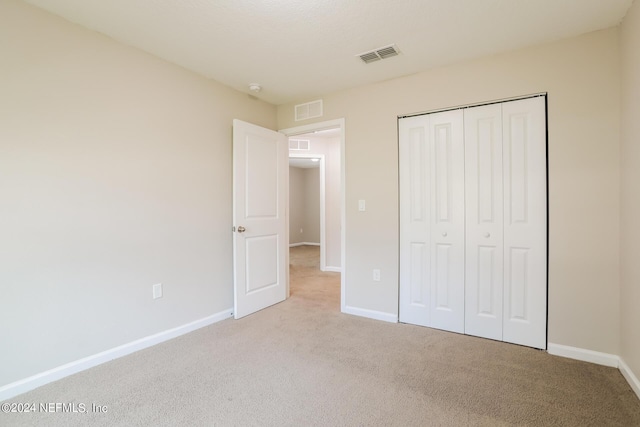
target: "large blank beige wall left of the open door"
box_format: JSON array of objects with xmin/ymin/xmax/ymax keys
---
[{"xmin": 0, "ymin": 0, "xmax": 276, "ymax": 386}]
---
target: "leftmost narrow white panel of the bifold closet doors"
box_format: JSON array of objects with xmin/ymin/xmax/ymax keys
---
[{"xmin": 398, "ymin": 115, "xmax": 431, "ymax": 326}]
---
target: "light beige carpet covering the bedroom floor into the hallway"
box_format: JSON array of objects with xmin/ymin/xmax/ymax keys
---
[{"xmin": 0, "ymin": 247, "xmax": 640, "ymax": 426}]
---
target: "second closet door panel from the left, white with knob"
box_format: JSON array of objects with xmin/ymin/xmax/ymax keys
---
[{"xmin": 428, "ymin": 110, "xmax": 464, "ymax": 333}]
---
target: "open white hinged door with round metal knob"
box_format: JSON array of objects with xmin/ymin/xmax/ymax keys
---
[{"xmin": 233, "ymin": 120, "xmax": 289, "ymax": 319}]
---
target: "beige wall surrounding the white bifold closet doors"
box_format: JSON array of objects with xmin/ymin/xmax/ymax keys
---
[{"xmin": 278, "ymin": 25, "xmax": 620, "ymax": 354}]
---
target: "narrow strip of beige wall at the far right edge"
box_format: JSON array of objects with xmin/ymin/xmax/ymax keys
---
[{"xmin": 620, "ymin": 0, "xmax": 640, "ymax": 378}]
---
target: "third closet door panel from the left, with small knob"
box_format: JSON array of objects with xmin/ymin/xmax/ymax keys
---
[{"xmin": 464, "ymin": 104, "xmax": 504, "ymax": 340}]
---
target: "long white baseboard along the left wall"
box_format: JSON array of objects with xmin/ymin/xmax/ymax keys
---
[{"xmin": 0, "ymin": 308, "xmax": 233, "ymax": 401}]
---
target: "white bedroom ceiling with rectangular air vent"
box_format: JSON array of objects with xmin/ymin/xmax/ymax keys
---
[{"xmin": 26, "ymin": 0, "xmax": 633, "ymax": 105}]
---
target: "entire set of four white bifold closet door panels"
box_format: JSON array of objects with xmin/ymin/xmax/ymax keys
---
[{"xmin": 398, "ymin": 96, "xmax": 547, "ymax": 349}]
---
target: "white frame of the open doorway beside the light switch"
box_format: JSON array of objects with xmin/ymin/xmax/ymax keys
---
[{"xmin": 280, "ymin": 119, "xmax": 347, "ymax": 312}]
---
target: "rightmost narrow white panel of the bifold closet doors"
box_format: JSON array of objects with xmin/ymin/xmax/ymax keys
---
[{"xmin": 502, "ymin": 97, "xmax": 547, "ymax": 349}]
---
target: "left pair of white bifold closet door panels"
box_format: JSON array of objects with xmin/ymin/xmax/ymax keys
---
[{"xmin": 399, "ymin": 110, "xmax": 464, "ymax": 332}]
